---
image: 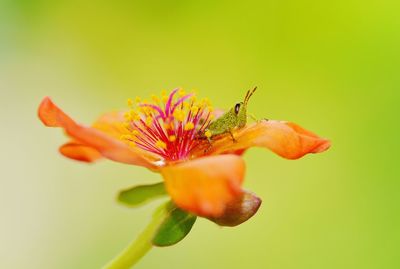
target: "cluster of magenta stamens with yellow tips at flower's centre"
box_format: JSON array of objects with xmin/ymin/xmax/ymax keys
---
[{"xmin": 121, "ymin": 89, "xmax": 213, "ymax": 161}]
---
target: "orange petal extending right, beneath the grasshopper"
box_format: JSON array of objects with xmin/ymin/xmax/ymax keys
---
[{"xmin": 207, "ymin": 120, "xmax": 330, "ymax": 159}]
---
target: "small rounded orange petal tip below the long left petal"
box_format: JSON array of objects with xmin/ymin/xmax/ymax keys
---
[{"xmin": 59, "ymin": 142, "xmax": 102, "ymax": 163}]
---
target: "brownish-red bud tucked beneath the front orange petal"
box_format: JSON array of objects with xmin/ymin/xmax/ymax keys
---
[{"xmin": 209, "ymin": 191, "xmax": 261, "ymax": 227}]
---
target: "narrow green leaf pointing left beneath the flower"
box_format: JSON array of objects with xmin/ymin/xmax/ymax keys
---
[{"xmin": 118, "ymin": 182, "xmax": 167, "ymax": 207}]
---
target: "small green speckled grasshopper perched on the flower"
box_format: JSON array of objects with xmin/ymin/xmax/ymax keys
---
[{"xmin": 201, "ymin": 87, "xmax": 257, "ymax": 145}]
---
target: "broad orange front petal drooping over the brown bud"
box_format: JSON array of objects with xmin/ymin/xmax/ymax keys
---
[{"xmin": 161, "ymin": 155, "xmax": 245, "ymax": 217}]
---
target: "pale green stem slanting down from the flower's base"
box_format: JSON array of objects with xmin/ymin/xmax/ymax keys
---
[{"xmin": 103, "ymin": 203, "xmax": 169, "ymax": 269}]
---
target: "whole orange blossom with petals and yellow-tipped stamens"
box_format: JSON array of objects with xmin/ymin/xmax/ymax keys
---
[{"xmin": 38, "ymin": 89, "xmax": 330, "ymax": 220}]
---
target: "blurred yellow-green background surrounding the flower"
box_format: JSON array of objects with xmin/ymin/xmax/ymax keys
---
[{"xmin": 0, "ymin": 0, "xmax": 400, "ymax": 269}]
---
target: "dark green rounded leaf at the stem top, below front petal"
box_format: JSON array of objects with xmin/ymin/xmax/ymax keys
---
[{"xmin": 152, "ymin": 203, "xmax": 197, "ymax": 247}]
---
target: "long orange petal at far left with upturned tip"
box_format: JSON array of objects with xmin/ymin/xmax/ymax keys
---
[{"xmin": 38, "ymin": 97, "xmax": 157, "ymax": 170}]
